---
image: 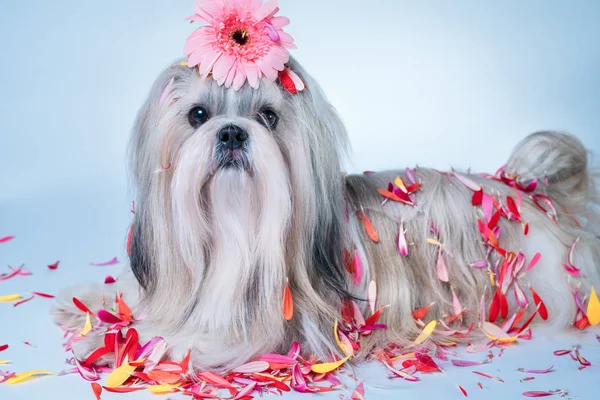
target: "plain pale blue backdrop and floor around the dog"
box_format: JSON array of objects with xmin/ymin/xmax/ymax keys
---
[{"xmin": 0, "ymin": 0, "xmax": 600, "ymax": 400}]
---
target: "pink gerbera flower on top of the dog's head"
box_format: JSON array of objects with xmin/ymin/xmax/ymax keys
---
[{"xmin": 184, "ymin": 0, "xmax": 296, "ymax": 91}]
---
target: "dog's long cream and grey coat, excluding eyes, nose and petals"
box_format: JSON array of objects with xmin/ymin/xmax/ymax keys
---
[{"xmin": 53, "ymin": 60, "xmax": 600, "ymax": 369}]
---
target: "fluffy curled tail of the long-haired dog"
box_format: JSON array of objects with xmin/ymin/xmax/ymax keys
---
[{"xmin": 505, "ymin": 131, "xmax": 600, "ymax": 231}]
